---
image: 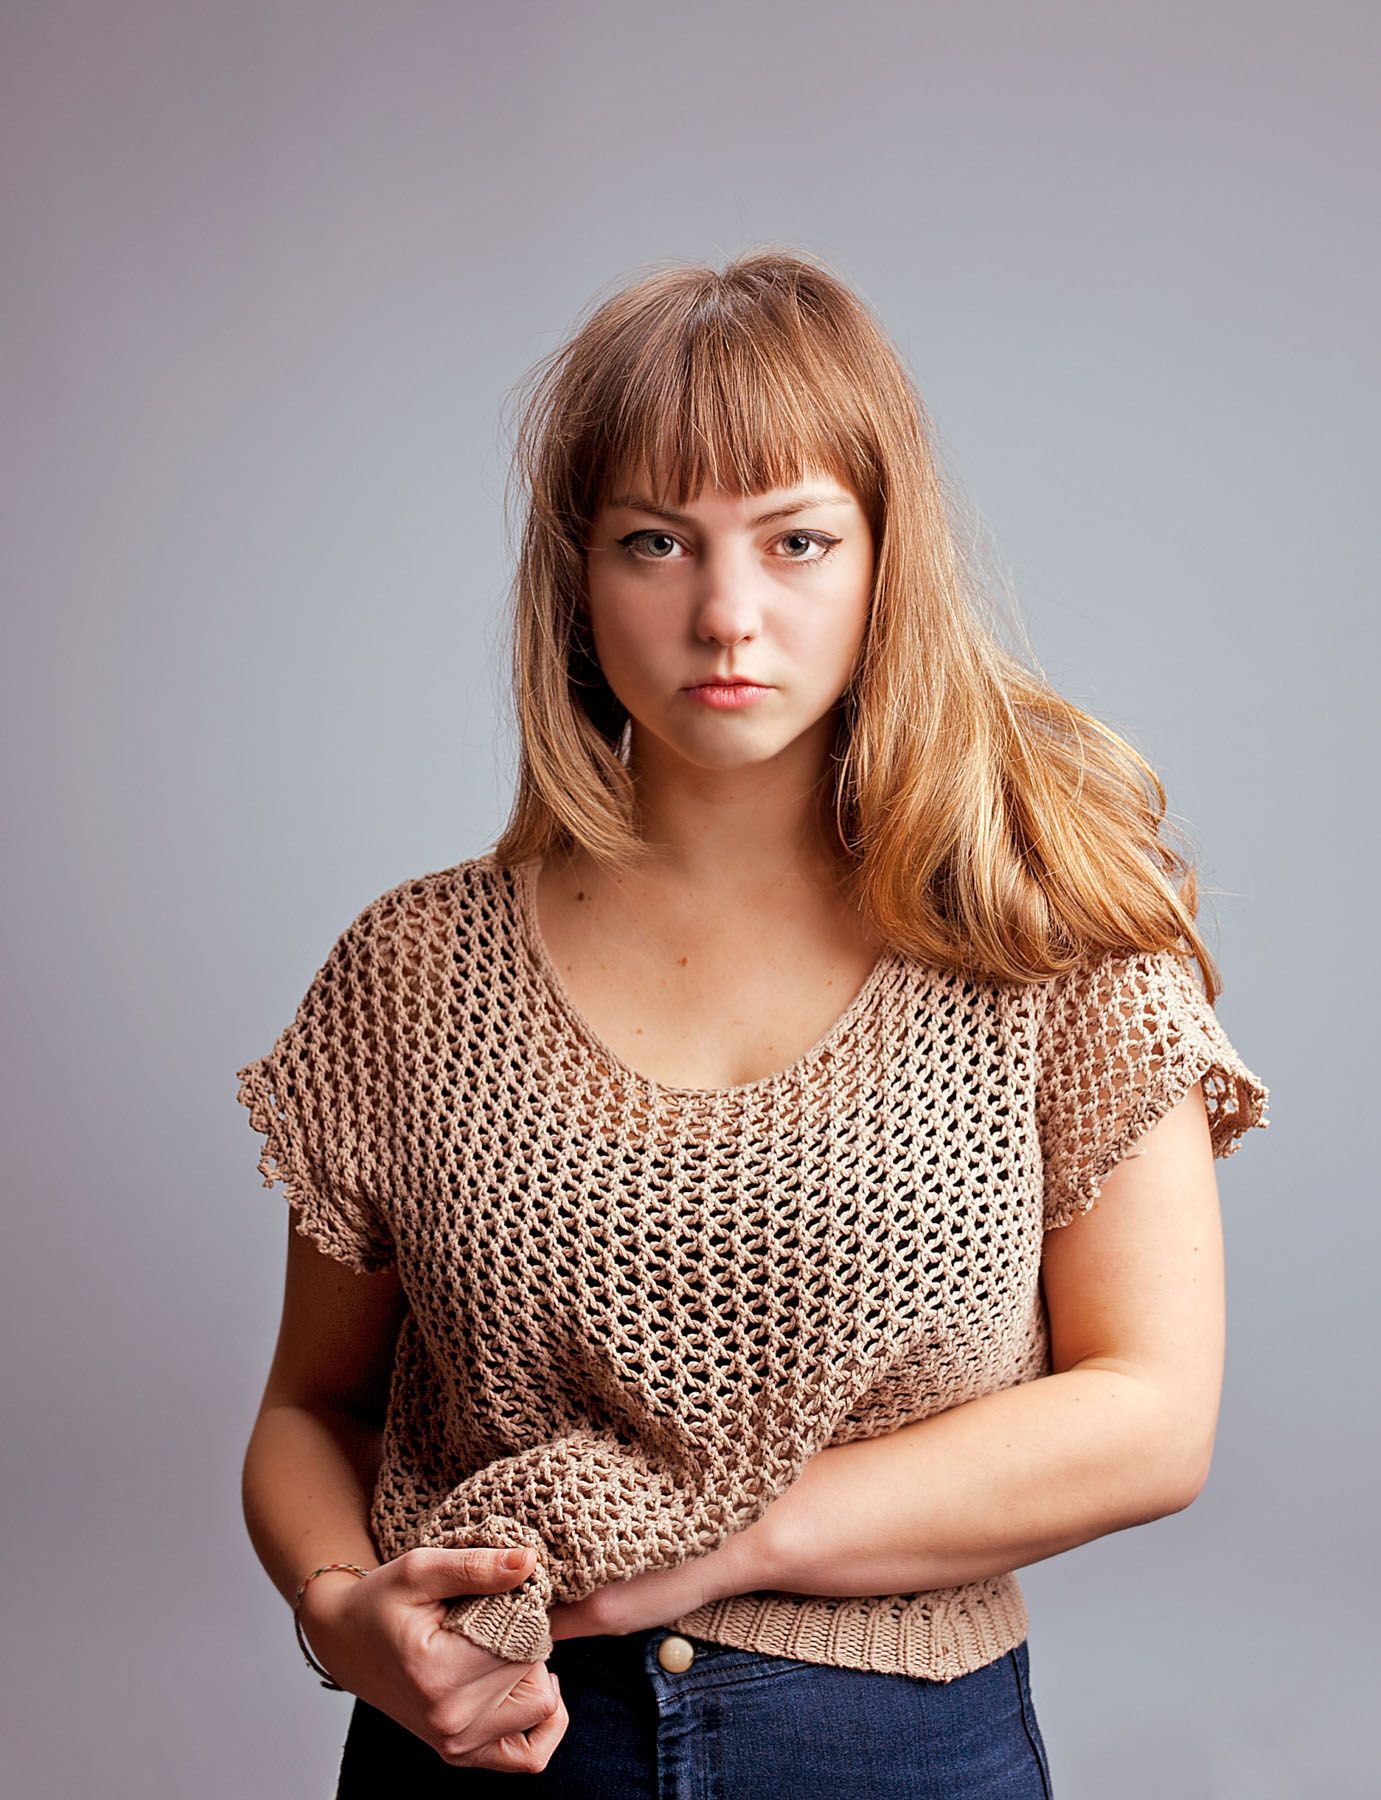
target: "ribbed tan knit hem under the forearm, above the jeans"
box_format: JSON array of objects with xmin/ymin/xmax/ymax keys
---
[{"xmin": 672, "ymin": 1573, "xmax": 1030, "ymax": 1681}]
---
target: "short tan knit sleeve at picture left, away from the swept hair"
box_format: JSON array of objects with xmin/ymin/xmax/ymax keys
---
[{"xmin": 236, "ymin": 909, "xmax": 396, "ymax": 1274}]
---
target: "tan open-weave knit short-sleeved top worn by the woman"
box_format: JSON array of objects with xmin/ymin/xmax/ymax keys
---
[{"xmin": 238, "ymin": 853, "xmax": 1268, "ymax": 1681}]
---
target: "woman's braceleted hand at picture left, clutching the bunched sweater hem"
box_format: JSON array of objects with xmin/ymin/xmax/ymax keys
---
[{"xmin": 301, "ymin": 1548, "xmax": 571, "ymax": 1775}]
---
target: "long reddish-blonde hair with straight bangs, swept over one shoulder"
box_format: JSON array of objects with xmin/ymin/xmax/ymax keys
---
[{"xmin": 493, "ymin": 247, "xmax": 1221, "ymax": 1003}]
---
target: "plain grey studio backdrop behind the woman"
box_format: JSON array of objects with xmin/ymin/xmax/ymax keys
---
[{"xmin": 0, "ymin": 0, "xmax": 1381, "ymax": 1800}]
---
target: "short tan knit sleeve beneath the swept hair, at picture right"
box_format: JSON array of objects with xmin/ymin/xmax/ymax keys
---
[{"xmin": 1037, "ymin": 950, "xmax": 1269, "ymax": 1231}]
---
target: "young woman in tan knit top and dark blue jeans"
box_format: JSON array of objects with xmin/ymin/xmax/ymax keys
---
[{"xmin": 239, "ymin": 250, "xmax": 1268, "ymax": 1800}]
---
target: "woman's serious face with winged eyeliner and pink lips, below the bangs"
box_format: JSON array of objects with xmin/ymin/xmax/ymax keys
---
[{"xmin": 585, "ymin": 473, "xmax": 873, "ymax": 769}]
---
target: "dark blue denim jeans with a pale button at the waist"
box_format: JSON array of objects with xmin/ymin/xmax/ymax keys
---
[{"xmin": 337, "ymin": 1625, "xmax": 1052, "ymax": 1800}]
